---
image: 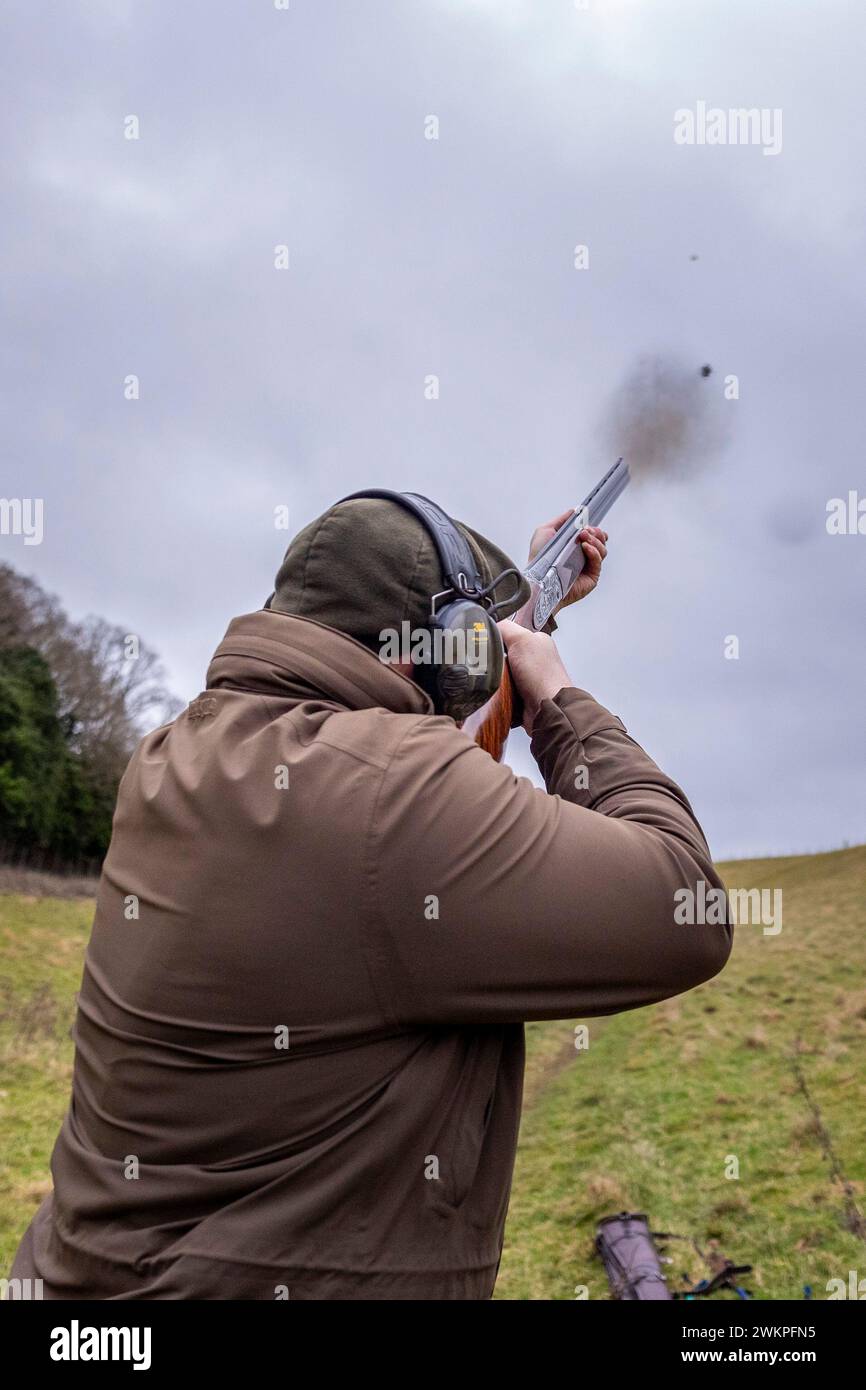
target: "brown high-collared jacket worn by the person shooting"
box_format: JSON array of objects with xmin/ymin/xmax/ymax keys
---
[{"xmin": 14, "ymin": 612, "xmax": 730, "ymax": 1300}]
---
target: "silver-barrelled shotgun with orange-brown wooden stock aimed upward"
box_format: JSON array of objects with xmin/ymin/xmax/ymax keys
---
[{"xmin": 463, "ymin": 459, "xmax": 628, "ymax": 762}]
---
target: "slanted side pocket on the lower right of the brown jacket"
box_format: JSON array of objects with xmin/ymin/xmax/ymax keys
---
[{"xmin": 428, "ymin": 1029, "xmax": 505, "ymax": 1213}]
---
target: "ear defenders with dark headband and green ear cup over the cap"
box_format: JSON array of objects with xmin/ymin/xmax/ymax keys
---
[{"xmin": 341, "ymin": 488, "xmax": 520, "ymax": 723}]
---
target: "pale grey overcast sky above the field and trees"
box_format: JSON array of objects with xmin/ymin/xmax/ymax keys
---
[{"xmin": 0, "ymin": 0, "xmax": 866, "ymax": 858}]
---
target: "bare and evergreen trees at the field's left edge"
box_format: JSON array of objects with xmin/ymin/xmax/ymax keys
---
[{"xmin": 0, "ymin": 564, "xmax": 178, "ymax": 870}]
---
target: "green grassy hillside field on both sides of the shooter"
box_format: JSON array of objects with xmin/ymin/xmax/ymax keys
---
[{"xmin": 0, "ymin": 847, "xmax": 866, "ymax": 1298}]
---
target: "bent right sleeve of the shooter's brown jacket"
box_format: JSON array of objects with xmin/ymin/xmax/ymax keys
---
[{"xmin": 367, "ymin": 688, "xmax": 731, "ymax": 1026}]
